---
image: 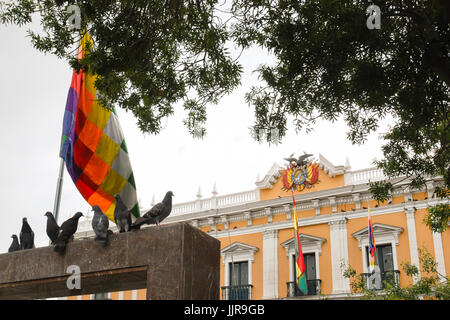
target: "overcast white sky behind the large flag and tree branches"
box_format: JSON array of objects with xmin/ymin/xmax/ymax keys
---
[{"xmin": 0, "ymin": 21, "xmax": 390, "ymax": 253}]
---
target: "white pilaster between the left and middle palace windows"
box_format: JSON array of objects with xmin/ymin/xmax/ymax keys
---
[{"xmin": 262, "ymin": 230, "xmax": 278, "ymax": 299}]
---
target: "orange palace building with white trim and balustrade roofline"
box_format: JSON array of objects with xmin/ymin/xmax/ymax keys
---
[{"xmin": 67, "ymin": 155, "xmax": 450, "ymax": 300}]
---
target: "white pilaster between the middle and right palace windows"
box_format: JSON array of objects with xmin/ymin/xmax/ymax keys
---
[{"xmin": 328, "ymin": 217, "xmax": 350, "ymax": 294}]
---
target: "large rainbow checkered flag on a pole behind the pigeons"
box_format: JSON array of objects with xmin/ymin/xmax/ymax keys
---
[{"xmin": 60, "ymin": 33, "xmax": 140, "ymax": 221}]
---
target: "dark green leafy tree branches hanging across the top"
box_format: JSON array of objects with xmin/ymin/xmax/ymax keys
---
[{"xmin": 0, "ymin": 0, "xmax": 450, "ymax": 231}]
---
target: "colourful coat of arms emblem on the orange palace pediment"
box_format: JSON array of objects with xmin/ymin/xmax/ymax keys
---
[{"xmin": 282, "ymin": 153, "xmax": 319, "ymax": 191}]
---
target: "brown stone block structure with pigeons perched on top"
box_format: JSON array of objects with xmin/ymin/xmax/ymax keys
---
[{"xmin": 0, "ymin": 223, "xmax": 220, "ymax": 300}]
